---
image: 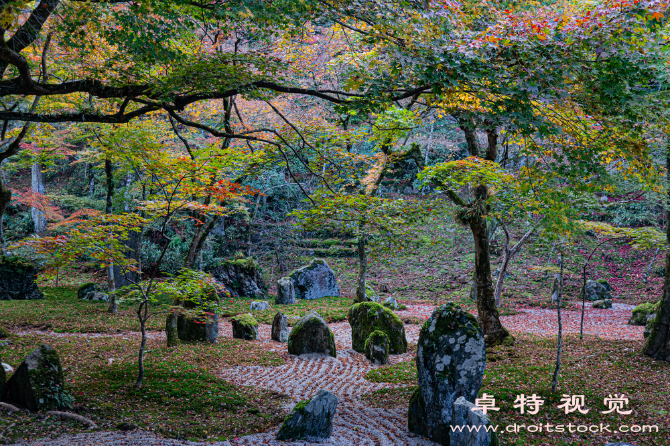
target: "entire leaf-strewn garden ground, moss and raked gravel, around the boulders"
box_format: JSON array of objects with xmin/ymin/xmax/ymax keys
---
[{"xmin": 0, "ymin": 226, "xmax": 670, "ymax": 446}]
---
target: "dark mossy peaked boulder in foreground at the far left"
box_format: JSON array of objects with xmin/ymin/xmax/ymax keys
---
[{"xmin": 5, "ymin": 345, "xmax": 72, "ymax": 411}]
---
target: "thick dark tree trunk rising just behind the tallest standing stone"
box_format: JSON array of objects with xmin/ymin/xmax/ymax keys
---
[{"xmin": 470, "ymin": 211, "xmax": 514, "ymax": 347}]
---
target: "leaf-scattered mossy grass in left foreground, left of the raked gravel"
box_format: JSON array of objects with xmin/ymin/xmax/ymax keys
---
[{"xmin": 0, "ymin": 334, "xmax": 286, "ymax": 443}]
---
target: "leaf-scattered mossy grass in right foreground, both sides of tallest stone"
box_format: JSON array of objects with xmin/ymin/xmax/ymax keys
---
[{"xmin": 363, "ymin": 333, "xmax": 670, "ymax": 446}]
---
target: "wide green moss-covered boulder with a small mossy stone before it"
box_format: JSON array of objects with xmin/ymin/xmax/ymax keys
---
[{"xmin": 347, "ymin": 302, "xmax": 407, "ymax": 355}]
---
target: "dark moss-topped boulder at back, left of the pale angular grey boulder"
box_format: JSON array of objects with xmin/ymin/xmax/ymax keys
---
[{"xmin": 209, "ymin": 256, "xmax": 268, "ymax": 298}]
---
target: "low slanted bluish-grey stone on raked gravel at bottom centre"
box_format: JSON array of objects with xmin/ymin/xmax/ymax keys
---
[{"xmin": 277, "ymin": 390, "xmax": 337, "ymax": 441}]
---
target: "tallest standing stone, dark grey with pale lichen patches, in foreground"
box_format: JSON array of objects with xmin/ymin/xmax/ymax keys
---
[{"xmin": 408, "ymin": 303, "xmax": 486, "ymax": 446}]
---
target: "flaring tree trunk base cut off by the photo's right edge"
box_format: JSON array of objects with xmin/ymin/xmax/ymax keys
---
[{"xmin": 643, "ymin": 140, "xmax": 670, "ymax": 362}]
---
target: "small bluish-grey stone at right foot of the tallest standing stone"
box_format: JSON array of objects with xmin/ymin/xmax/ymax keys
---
[{"xmin": 450, "ymin": 396, "xmax": 498, "ymax": 446}]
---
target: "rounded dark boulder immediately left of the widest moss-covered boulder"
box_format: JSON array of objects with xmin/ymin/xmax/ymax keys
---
[{"xmin": 288, "ymin": 311, "xmax": 337, "ymax": 358}]
